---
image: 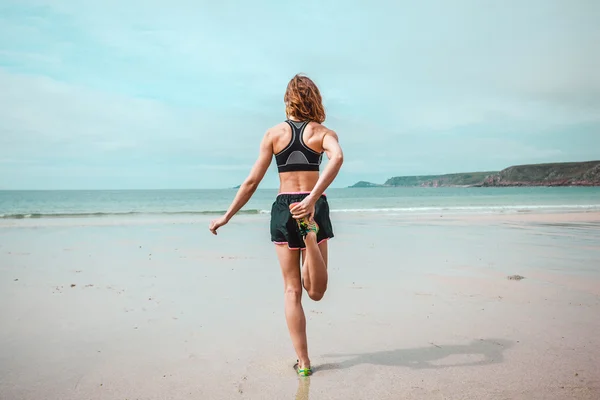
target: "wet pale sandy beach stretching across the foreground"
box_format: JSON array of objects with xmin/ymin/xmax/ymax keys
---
[{"xmin": 0, "ymin": 212, "xmax": 600, "ymax": 400}]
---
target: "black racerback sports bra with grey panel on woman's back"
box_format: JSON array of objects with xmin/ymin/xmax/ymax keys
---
[{"xmin": 275, "ymin": 119, "xmax": 323, "ymax": 172}]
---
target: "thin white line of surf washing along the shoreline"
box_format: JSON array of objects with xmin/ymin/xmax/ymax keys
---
[{"xmin": 0, "ymin": 204, "xmax": 600, "ymax": 219}]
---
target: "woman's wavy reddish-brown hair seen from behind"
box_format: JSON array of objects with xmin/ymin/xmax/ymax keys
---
[{"xmin": 283, "ymin": 74, "xmax": 325, "ymax": 123}]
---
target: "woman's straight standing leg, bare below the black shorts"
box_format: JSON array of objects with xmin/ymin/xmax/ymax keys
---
[{"xmin": 275, "ymin": 245, "xmax": 310, "ymax": 368}]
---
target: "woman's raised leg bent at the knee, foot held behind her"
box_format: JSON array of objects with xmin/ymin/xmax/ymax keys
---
[{"xmin": 302, "ymin": 232, "xmax": 328, "ymax": 301}]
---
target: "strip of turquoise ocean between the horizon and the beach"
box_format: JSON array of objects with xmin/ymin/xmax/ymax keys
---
[{"xmin": 0, "ymin": 187, "xmax": 600, "ymax": 219}]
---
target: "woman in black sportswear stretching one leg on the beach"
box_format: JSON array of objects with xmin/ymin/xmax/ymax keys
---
[{"xmin": 210, "ymin": 75, "xmax": 343, "ymax": 376}]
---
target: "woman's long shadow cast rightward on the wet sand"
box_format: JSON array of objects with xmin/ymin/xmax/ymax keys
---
[{"xmin": 314, "ymin": 339, "xmax": 513, "ymax": 372}]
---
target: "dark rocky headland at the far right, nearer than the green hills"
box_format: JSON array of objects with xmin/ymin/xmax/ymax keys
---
[{"xmin": 476, "ymin": 161, "xmax": 600, "ymax": 186}]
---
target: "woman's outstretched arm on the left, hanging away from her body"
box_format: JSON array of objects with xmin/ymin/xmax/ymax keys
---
[{"xmin": 209, "ymin": 131, "xmax": 273, "ymax": 235}]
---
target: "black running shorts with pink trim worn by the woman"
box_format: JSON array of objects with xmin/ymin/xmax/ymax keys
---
[{"xmin": 271, "ymin": 193, "xmax": 333, "ymax": 250}]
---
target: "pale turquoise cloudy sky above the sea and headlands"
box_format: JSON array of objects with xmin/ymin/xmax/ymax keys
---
[{"xmin": 0, "ymin": 0, "xmax": 600, "ymax": 189}]
